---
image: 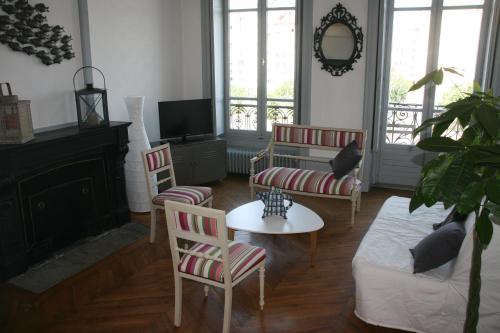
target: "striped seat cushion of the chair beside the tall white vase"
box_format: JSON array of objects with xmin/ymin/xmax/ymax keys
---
[{"xmin": 153, "ymin": 186, "xmax": 212, "ymax": 206}]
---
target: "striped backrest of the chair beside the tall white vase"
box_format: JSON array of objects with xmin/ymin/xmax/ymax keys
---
[{"xmin": 142, "ymin": 143, "xmax": 176, "ymax": 199}]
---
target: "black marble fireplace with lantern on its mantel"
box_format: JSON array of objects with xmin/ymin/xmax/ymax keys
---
[{"xmin": 0, "ymin": 122, "xmax": 130, "ymax": 281}]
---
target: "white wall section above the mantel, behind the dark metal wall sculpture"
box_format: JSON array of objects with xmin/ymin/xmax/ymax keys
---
[{"xmin": 0, "ymin": 0, "xmax": 82, "ymax": 129}]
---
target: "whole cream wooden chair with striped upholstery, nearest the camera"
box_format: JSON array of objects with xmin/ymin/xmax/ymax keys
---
[{"xmin": 165, "ymin": 201, "xmax": 266, "ymax": 332}]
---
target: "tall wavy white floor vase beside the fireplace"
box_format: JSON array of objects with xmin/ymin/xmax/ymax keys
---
[{"xmin": 125, "ymin": 96, "xmax": 151, "ymax": 213}]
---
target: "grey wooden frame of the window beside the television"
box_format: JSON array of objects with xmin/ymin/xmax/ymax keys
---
[{"xmin": 223, "ymin": 0, "xmax": 302, "ymax": 141}]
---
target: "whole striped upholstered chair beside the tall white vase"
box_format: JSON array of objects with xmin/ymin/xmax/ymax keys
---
[{"xmin": 142, "ymin": 143, "xmax": 213, "ymax": 243}]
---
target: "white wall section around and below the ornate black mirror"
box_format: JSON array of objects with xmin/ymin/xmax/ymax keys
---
[{"xmin": 311, "ymin": 0, "xmax": 368, "ymax": 128}]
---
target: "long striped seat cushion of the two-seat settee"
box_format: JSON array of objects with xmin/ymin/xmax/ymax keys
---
[{"xmin": 253, "ymin": 167, "xmax": 360, "ymax": 196}]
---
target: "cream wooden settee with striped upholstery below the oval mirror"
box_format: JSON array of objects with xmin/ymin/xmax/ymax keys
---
[{"xmin": 249, "ymin": 124, "xmax": 366, "ymax": 224}]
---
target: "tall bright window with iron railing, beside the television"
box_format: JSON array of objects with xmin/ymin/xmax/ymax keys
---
[{"xmin": 225, "ymin": 0, "xmax": 298, "ymax": 137}]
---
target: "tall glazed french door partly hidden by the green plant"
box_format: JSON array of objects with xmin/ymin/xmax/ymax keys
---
[{"xmin": 375, "ymin": 0, "xmax": 490, "ymax": 186}]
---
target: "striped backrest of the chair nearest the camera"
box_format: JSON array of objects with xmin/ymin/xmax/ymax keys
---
[{"xmin": 165, "ymin": 201, "xmax": 231, "ymax": 281}]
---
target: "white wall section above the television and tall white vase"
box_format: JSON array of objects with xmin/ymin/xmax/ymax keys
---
[{"xmin": 88, "ymin": 0, "xmax": 203, "ymax": 140}]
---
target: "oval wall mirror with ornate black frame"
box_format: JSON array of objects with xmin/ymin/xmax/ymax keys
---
[{"xmin": 314, "ymin": 3, "xmax": 363, "ymax": 76}]
